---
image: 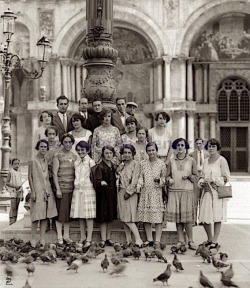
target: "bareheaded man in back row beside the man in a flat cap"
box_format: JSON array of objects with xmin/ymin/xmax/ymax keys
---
[{"xmin": 113, "ymin": 97, "xmax": 130, "ymax": 135}]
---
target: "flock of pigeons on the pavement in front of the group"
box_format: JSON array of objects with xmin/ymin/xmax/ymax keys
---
[{"xmin": 0, "ymin": 238, "xmax": 238, "ymax": 288}]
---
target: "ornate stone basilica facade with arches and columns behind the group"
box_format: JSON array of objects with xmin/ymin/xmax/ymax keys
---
[{"xmin": 0, "ymin": 0, "xmax": 250, "ymax": 172}]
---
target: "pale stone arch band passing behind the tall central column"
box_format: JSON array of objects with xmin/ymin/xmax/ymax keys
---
[{"xmin": 53, "ymin": 5, "xmax": 170, "ymax": 57}]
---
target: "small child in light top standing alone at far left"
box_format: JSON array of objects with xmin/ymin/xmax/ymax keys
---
[{"xmin": 6, "ymin": 158, "xmax": 23, "ymax": 225}]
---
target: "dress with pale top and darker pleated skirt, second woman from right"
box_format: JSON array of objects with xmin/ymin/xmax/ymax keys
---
[{"xmin": 165, "ymin": 155, "xmax": 198, "ymax": 223}]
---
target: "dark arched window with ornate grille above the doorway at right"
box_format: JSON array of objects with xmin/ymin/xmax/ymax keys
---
[{"xmin": 218, "ymin": 77, "xmax": 250, "ymax": 122}]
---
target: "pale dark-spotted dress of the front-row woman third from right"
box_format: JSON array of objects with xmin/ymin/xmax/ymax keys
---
[{"xmin": 138, "ymin": 159, "xmax": 166, "ymax": 223}]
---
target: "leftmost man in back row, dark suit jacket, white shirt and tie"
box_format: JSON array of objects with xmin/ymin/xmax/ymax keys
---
[{"xmin": 53, "ymin": 95, "xmax": 74, "ymax": 140}]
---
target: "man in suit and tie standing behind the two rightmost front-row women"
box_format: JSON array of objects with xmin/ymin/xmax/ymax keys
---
[{"xmin": 189, "ymin": 138, "xmax": 209, "ymax": 224}]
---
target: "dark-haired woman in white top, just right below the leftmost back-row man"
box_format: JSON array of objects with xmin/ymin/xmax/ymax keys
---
[{"xmin": 69, "ymin": 113, "xmax": 92, "ymax": 157}]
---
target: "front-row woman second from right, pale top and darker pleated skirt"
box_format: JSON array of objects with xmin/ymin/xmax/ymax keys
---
[{"xmin": 165, "ymin": 138, "xmax": 198, "ymax": 250}]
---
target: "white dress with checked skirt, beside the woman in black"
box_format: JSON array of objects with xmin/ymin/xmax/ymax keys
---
[{"xmin": 70, "ymin": 155, "xmax": 96, "ymax": 219}]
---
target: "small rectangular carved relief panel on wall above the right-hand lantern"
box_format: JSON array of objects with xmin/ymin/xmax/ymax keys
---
[{"xmin": 39, "ymin": 9, "xmax": 54, "ymax": 40}]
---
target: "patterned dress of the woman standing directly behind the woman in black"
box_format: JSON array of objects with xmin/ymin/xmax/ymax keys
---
[{"xmin": 92, "ymin": 125, "xmax": 121, "ymax": 163}]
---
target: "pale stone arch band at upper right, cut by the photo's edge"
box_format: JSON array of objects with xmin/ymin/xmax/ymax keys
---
[{"xmin": 174, "ymin": 0, "xmax": 250, "ymax": 56}]
